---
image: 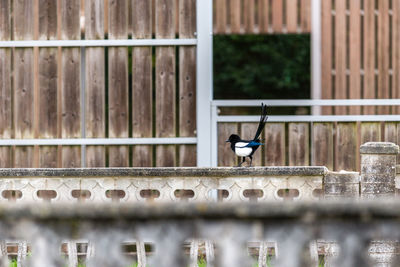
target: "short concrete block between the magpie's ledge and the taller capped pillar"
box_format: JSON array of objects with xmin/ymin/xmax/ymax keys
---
[{"xmin": 324, "ymin": 171, "xmax": 360, "ymax": 199}]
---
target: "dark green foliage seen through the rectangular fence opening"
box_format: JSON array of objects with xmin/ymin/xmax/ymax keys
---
[{"xmin": 214, "ymin": 35, "xmax": 310, "ymax": 99}]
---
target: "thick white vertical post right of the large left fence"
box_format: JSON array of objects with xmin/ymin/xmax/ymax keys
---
[{"xmin": 196, "ymin": 0, "xmax": 213, "ymax": 167}]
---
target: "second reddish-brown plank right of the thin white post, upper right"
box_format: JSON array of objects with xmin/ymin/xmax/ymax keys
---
[{"xmin": 335, "ymin": 0, "xmax": 347, "ymax": 115}]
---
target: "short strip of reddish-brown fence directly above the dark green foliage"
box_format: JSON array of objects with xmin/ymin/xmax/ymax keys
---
[{"xmin": 214, "ymin": 0, "xmax": 311, "ymax": 34}]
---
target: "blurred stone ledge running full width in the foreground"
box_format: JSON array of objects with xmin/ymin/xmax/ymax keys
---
[{"xmin": 0, "ymin": 199, "xmax": 400, "ymax": 223}]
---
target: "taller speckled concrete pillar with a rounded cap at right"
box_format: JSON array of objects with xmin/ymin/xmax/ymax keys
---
[{"xmin": 360, "ymin": 142, "xmax": 399, "ymax": 199}]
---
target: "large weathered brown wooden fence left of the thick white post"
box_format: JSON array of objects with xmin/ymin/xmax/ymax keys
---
[{"xmin": 0, "ymin": 0, "xmax": 196, "ymax": 167}]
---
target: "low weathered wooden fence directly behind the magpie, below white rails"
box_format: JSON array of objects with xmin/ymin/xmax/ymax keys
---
[{"xmin": 218, "ymin": 122, "xmax": 400, "ymax": 171}]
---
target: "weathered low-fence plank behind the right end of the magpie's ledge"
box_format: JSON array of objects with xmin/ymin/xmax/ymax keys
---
[{"xmin": 312, "ymin": 122, "xmax": 334, "ymax": 170}]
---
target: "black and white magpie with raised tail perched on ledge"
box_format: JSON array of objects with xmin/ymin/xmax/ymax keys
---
[{"xmin": 226, "ymin": 103, "xmax": 268, "ymax": 167}]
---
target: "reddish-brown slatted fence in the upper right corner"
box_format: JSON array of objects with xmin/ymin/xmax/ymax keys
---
[{"xmin": 321, "ymin": 0, "xmax": 400, "ymax": 115}]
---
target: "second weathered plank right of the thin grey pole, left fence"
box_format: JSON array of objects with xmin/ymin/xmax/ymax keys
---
[{"xmin": 108, "ymin": 0, "xmax": 129, "ymax": 167}]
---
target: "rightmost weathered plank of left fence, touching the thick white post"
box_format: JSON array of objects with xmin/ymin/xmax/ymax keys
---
[{"xmin": 179, "ymin": 0, "xmax": 197, "ymax": 166}]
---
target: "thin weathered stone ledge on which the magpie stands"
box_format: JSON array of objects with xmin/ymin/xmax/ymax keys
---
[{"xmin": 0, "ymin": 166, "xmax": 328, "ymax": 178}]
